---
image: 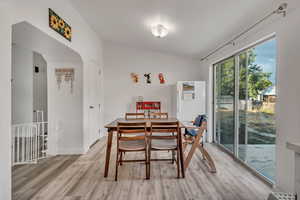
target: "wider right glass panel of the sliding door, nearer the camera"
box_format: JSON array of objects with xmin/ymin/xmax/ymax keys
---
[{"xmin": 238, "ymin": 39, "xmax": 276, "ymax": 182}]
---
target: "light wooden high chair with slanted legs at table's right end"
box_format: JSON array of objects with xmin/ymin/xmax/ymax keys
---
[{"xmin": 183, "ymin": 121, "xmax": 217, "ymax": 173}]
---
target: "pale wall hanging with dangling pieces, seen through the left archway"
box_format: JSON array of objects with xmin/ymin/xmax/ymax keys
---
[{"xmin": 55, "ymin": 68, "xmax": 75, "ymax": 93}]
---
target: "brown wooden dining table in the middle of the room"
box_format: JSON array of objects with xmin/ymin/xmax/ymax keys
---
[{"xmin": 104, "ymin": 118, "xmax": 185, "ymax": 178}]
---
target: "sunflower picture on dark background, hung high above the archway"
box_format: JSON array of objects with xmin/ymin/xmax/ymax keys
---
[{"xmin": 49, "ymin": 8, "xmax": 72, "ymax": 42}]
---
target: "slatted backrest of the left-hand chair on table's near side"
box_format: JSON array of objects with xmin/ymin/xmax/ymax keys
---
[{"xmin": 117, "ymin": 122, "xmax": 147, "ymax": 144}]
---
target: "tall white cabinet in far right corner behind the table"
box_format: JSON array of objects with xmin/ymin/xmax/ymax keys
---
[{"xmin": 175, "ymin": 81, "xmax": 206, "ymax": 121}]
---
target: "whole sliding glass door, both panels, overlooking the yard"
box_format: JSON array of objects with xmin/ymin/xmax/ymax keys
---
[{"xmin": 214, "ymin": 39, "xmax": 276, "ymax": 182}]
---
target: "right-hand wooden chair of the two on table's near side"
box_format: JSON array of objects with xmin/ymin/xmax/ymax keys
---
[{"xmin": 148, "ymin": 121, "xmax": 180, "ymax": 178}]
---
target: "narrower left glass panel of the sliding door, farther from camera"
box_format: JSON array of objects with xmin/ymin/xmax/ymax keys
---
[{"xmin": 215, "ymin": 57, "xmax": 235, "ymax": 152}]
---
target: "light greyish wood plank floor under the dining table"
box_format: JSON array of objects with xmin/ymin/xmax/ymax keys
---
[{"xmin": 12, "ymin": 138, "xmax": 271, "ymax": 200}]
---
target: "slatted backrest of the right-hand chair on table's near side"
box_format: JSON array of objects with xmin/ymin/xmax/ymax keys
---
[{"xmin": 149, "ymin": 121, "xmax": 179, "ymax": 139}]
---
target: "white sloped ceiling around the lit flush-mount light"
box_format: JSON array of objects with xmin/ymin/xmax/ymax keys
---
[{"xmin": 72, "ymin": 0, "xmax": 280, "ymax": 58}]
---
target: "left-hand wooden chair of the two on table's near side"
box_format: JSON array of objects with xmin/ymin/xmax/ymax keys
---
[{"xmin": 115, "ymin": 122, "xmax": 149, "ymax": 181}]
